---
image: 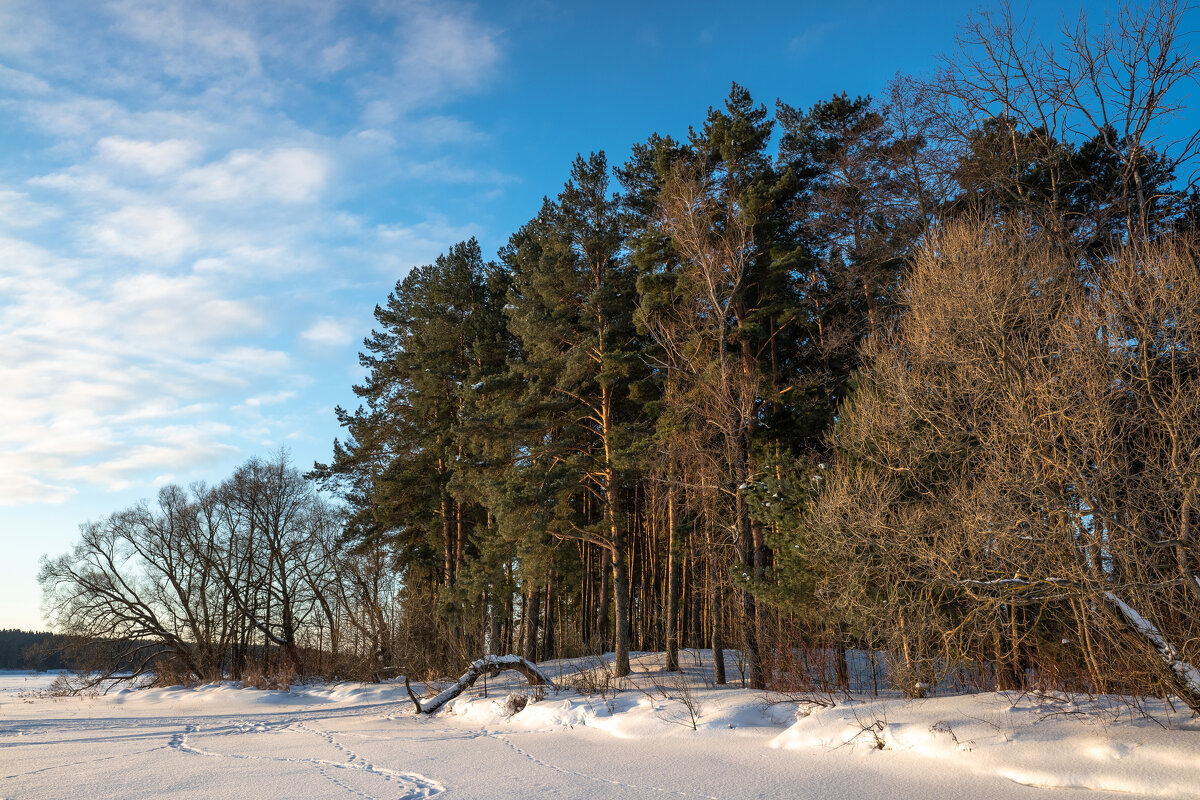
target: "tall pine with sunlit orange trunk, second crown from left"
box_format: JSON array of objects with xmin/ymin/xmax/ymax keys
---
[{"xmin": 504, "ymin": 154, "xmax": 640, "ymax": 675}]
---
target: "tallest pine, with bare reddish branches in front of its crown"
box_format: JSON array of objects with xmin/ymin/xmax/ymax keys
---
[{"xmin": 625, "ymin": 84, "xmax": 806, "ymax": 687}]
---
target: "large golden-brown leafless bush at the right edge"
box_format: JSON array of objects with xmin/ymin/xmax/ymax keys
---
[{"xmin": 810, "ymin": 219, "xmax": 1200, "ymax": 708}]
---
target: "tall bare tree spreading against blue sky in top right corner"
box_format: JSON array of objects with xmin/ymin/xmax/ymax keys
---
[{"xmin": 926, "ymin": 0, "xmax": 1200, "ymax": 239}]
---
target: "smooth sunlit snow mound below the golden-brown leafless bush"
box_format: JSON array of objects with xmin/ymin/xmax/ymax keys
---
[{"xmin": 770, "ymin": 693, "xmax": 1200, "ymax": 798}]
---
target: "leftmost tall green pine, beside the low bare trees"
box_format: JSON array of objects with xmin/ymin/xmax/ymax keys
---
[{"xmin": 313, "ymin": 240, "xmax": 506, "ymax": 662}]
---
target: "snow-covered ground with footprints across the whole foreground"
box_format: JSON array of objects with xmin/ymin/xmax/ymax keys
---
[{"xmin": 0, "ymin": 652, "xmax": 1200, "ymax": 800}]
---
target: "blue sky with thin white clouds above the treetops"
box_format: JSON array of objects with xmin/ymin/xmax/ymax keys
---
[{"xmin": 0, "ymin": 0, "xmax": 1147, "ymax": 627}]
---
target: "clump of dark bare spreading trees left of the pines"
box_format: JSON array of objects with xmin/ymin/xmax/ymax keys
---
[{"xmin": 40, "ymin": 453, "xmax": 396, "ymax": 680}]
